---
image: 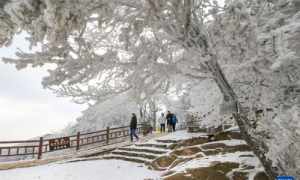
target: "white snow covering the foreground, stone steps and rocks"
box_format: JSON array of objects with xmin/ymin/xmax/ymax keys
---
[{"xmin": 0, "ymin": 131, "xmax": 264, "ymax": 180}]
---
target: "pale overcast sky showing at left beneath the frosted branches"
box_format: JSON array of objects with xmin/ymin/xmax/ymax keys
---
[{"xmin": 0, "ymin": 33, "xmax": 85, "ymax": 141}]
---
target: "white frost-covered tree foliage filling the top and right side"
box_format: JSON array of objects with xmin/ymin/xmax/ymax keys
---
[{"xmin": 0, "ymin": 0, "xmax": 300, "ymax": 176}]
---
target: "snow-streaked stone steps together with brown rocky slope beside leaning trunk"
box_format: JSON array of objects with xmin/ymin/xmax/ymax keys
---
[{"xmin": 102, "ymin": 129, "xmax": 268, "ymax": 180}]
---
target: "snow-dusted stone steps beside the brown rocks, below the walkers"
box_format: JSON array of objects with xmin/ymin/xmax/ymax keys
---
[{"xmin": 103, "ymin": 140, "xmax": 177, "ymax": 164}]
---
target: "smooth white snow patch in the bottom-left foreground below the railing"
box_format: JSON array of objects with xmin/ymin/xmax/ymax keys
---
[{"xmin": 0, "ymin": 160, "xmax": 160, "ymax": 180}]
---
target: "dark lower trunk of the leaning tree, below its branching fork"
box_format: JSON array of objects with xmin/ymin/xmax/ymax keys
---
[{"xmin": 207, "ymin": 56, "xmax": 278, "ymax": 179}]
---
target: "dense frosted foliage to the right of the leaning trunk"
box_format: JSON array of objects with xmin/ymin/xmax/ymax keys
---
[{"xmin": 212, "ymin": 1, "xmax": 300, "ymax": 176}]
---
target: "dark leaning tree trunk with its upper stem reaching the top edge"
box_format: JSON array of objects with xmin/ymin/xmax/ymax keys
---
[{"xmin": 159, "ymin": 0, "xmax": 278, "ymax": 176}]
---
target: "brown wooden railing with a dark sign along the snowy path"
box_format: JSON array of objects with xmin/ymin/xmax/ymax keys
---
[{"xmin": 0, "ymin": 124, "xmax": 142, "ymax": 159}]
